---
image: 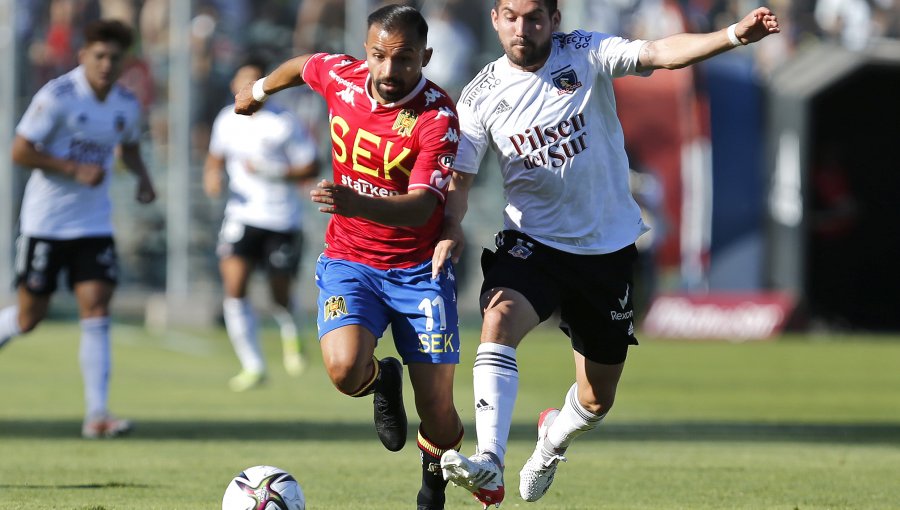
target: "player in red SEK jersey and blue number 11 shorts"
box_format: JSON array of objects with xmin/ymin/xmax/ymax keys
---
[{"xmin": 236, "ymin": 5, "xmax": 463, "ymax": 510}]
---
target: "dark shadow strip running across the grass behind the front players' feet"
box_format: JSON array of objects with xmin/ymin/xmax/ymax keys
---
[{"xmin": 0, "ymin": 418, "xmax": 900, "ymax": 444}]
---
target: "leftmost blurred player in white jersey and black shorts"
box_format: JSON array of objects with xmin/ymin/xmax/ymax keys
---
[{"xmin": 0, "ymin": 20, "xmax": 156, "ymax": 438}]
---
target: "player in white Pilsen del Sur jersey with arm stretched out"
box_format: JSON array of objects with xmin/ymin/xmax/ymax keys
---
[{"xmin": 433, "ymin": 0, "xmax": 779, "ymax": 508}]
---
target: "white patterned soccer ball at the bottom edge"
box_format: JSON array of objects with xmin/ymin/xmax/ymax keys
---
[{"xmin": 222, "ymin": 466, "xmax": 306, "ymax": 510}]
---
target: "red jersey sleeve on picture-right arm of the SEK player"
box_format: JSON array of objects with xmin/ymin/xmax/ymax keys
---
[{"xmin": 408, "ymin": 97, "xmax": 459, "ymax": 202}]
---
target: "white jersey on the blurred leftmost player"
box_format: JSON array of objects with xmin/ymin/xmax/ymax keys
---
[{"xmin": 16, "ymin": 67, "xmax": 140, "ymax": 239}]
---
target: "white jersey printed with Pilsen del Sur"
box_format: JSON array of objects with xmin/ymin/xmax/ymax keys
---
[{"xmin": 453, "ymin": 31, "xmax": 647, "ymax": 254}]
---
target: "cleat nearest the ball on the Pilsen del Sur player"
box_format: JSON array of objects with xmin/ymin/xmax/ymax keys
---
[{"xmin": 441, "ymin": 450, "xmax": 506, "ymax": 508}]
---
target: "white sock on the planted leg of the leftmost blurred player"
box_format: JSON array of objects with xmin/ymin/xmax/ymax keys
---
[{"xmin": 78, "ymin": 317, "xmax": 112, "ymax": 418}]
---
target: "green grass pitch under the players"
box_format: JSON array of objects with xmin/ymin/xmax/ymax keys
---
[{"xmin": 0, "ymin": 322, "xmax": 900, "ymax": 510}]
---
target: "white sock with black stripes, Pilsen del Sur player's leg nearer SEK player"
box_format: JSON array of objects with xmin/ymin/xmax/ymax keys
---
[{"xmin": 472, "ymin": 343, "xmax": 519, "ymax": 465}]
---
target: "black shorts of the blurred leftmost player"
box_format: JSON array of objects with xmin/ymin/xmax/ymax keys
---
[{"xmin": 16, "ymin": 236, "xmax": 119, "ymax": 294}]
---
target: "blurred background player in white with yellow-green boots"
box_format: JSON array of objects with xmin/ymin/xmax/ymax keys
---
[{"xmin": 203, "ymin": 58, "xmax": 318, "ymax": 391}]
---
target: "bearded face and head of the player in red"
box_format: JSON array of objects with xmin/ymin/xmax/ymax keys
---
[{"xmin": 366, "ymin": 25, "xmax": 430, "ymax": 103}]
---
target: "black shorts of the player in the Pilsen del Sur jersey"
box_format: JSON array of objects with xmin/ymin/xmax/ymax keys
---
[{"xmin": 481, "ymin": 230, "xmax": 638, "ymax": 365}]
